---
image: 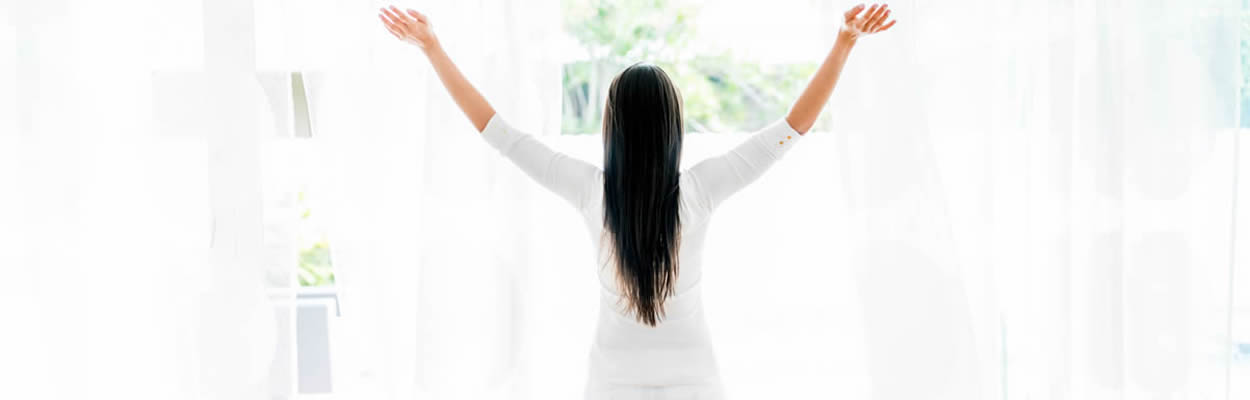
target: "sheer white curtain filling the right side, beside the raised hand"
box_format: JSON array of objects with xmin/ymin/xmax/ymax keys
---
[{"xmin": 809, "ymin": 1, "xmax": 1246, "ymax": 399}]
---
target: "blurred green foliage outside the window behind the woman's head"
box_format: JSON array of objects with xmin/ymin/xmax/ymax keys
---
[{"xmin": 563, "ymin": 0, "xmax": 816, "ymax": 135}]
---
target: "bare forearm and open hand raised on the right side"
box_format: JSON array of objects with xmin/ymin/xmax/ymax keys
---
[{"xmin": 785, "ymin": 4, "xmax": 895, "ymax": 134}]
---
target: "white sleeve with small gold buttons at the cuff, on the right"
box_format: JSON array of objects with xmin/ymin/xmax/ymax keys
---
[{"xmin": 686, "ymin": 119, "xmax": 803, "ymax": 211}]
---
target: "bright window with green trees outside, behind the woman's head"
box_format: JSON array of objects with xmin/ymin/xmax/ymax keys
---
[{"xmin": 561, "ymin": 0, "xmax": 836, "ymax": 135}]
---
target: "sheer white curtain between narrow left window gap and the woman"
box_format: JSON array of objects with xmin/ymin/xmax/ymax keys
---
[{"xmin": 297, "ymin": 1, "xmax": 567, "ymax": 399}]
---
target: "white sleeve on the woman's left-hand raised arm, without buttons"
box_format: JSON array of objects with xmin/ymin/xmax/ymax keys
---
[{"xmin": 481, "ymin": 113, "xmax": 599, "ymax": 210}]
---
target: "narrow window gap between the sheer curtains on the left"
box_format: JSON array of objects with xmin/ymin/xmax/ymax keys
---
[{"xmin": 259, "ymin": 73, "xmax": 338, "ymax": 395}]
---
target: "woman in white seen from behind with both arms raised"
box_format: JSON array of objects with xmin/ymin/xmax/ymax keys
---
[{"xmin": 379, "ymin": 5, "xmax": 894, "ymax": 399}]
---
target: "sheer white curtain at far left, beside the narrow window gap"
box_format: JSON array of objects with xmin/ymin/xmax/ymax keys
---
[{"xmin": 0, "ymin": 0, "xmax": 283, "ymax": 399}]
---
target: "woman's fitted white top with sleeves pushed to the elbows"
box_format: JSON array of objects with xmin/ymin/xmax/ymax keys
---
[{"xmin": 481, "ymin": 114, "xmax": 803, "ymax": 398}]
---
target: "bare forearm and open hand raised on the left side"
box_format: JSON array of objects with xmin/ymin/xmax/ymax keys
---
[{"xmin": 378, "ymin": 5, "xmax": 495, "ymax": 133}]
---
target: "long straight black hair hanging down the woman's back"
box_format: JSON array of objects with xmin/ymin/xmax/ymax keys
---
[{"xmin": 604, "ymin": 64, "xmax": 685, "ymax": 326}]
